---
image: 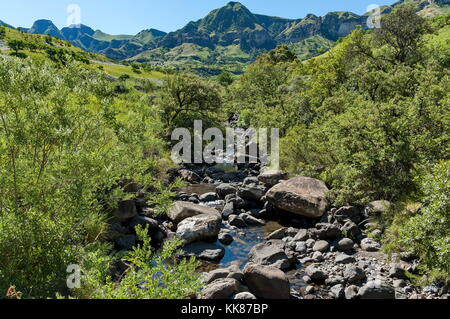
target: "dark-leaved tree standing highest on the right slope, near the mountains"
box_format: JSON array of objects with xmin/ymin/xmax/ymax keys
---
[{"xmin": 375, "ymin": 5, "xmax": 430, "ymax": 63}]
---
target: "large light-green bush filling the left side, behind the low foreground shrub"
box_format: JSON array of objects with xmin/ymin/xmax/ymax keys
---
[{"xmin": 0, "ymin": 57, "xmax": 168, "ymax": 298}]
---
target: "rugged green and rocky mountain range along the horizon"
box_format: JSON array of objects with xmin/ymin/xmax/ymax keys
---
[{"xmin": 0, "ymin": 0, "xmax": 450, "ymax": 69}]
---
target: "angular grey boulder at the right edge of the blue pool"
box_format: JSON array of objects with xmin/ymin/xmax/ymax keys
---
[{"xmin": 248, "ymin": 239, "xmax": 291, "ymax": 269}]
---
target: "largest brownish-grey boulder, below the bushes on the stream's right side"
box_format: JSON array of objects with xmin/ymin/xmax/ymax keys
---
[{"xmin": 266, "ymin": 177, "xmax": 330, "ymax": 218}]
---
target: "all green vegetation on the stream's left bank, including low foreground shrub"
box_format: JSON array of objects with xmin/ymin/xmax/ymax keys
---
[{"xmin": 0, "ymin": 41, "xmax": 211, "ymax": 298}]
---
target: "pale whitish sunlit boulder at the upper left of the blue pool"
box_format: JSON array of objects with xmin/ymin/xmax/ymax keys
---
[{"xmin": 176, "ymin": 210, "xmax": 222, "ymax": 244}]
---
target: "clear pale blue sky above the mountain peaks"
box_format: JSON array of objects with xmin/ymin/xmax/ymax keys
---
[{"xmin": 0, "ymin": 0, "xmax": 395, "ymax": 34}]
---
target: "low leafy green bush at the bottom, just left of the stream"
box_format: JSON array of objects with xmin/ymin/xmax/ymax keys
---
[{"xmin": 73, "ymin": 226, "xmax": 201, "ymax": 299}]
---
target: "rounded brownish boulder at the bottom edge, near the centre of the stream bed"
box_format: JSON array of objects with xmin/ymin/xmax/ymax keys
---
[{"xmin": 244, "ymin": 263, "xmax": 291, "ymax": 299}]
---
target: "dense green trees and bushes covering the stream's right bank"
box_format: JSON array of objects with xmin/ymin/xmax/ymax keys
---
[{"xmin": 226, "ymin": 5, "xmax": 450, "ymax": 279}]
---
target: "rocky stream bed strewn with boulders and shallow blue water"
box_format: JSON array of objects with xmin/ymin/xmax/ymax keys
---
[{"xmin": 107, "ymin": 164, "xmax": 448, "ymax": 299}]
